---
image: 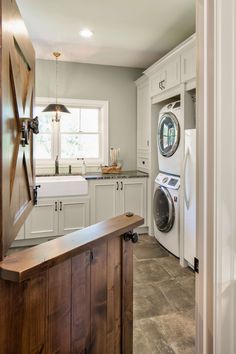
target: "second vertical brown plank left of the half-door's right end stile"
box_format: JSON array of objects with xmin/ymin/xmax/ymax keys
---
[{"xmin": 89, "ymin": 242, "xmax": 109, "ymax": 354}]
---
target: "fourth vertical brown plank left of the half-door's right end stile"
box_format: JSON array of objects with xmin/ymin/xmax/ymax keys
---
[{"xmin": 47, "ymin": 260, "xmax": 72, "ymax": 354}]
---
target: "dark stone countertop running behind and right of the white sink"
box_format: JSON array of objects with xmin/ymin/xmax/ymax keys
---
[{"xmin": 36, "ymin": 170, "xmax": 148, "ymax": 180}]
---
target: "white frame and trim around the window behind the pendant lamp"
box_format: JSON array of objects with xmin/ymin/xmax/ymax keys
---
[{"xmin": 35, "ymin": 97, "xmax": 109, "ymax": 168}]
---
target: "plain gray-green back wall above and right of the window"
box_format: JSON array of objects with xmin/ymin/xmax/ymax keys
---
[{"xmin": 36, "ymin": 60, "xmax": 142, "ymax": 170}]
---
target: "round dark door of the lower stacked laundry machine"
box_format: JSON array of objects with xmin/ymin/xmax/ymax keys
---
[{"xmin": 153, "ymin": 186, "xmax": 175, "ymax": 232}]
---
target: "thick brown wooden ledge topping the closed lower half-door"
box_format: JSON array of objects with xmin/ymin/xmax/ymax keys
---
[{"xmin": 0, "ymin": 214, "xmax": 144, "ymax": 282}]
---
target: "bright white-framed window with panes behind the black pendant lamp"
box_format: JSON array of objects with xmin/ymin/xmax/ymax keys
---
[{"xmin": 35, "ymin": 98, "xmax": 108, "ymax": 166}]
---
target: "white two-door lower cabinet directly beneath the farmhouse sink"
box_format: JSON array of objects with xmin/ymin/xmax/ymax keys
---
[{"xmin": 25, "ymin": 197, "xmax": 89, "ymax": 239}]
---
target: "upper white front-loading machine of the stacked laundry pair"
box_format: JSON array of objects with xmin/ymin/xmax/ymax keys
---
[{"xmin": 157, "ymin": 101, "xmax": 183, "ymax": 176}]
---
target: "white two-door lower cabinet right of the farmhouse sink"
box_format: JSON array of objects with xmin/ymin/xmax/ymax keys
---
[{"xmin": 89, "ymin": 178, "xmax": 147, "ymax": 224}]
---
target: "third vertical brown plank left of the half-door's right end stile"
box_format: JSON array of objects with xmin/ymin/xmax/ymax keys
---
[{"xmin": 71, "ymin": 251, "xmax": 91, "ymax": 354}]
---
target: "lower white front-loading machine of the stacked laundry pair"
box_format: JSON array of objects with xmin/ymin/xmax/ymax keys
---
[{"xmin": 153, "ymin": 173, "xmax": 180, "ymax": 257}]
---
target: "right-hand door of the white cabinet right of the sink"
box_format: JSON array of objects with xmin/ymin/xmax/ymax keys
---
[{"xmin": 120, "ymin": 178, "xmax": 146, "ymax": 224}]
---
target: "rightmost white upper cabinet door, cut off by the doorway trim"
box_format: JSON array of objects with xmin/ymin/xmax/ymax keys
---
[{"xmin": 181, "ymin": 46, "xmax": 196, "ymax": 82}]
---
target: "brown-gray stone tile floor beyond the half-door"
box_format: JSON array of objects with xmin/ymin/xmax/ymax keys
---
[{"xmin": 133, "ymin": 235, "xmax": 195, "ymax": 354}]
